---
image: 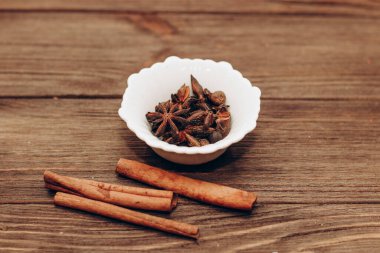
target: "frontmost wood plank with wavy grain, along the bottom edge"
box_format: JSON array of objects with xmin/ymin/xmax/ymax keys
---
[{"xmin": 0, "ymin": 203, "xmax": 380, "ymax": 252}]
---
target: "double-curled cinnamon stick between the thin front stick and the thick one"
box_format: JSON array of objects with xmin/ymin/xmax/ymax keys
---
[{"xmin": 44, "ymin": 171, "xmax": 177, "ymax": 211}]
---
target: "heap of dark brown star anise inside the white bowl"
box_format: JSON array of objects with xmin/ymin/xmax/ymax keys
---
[{"xmin": 145, "ymin": 75, "xmax": 231, "ymax": 147}]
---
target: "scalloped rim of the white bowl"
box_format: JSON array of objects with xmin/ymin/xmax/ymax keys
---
[{"xmin": 118, "ymin": 56, "xmax": 261, "ymax": 155}]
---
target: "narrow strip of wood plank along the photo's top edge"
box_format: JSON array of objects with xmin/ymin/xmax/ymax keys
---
[{"xmin": 0, "ymin": 0, "xmax": 380, "ymax": 17}]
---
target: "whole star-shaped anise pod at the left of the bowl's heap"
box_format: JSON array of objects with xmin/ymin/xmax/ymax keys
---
[{"xmin": 145, "ymin": 101, "xmax": 190, "ymax": 137}]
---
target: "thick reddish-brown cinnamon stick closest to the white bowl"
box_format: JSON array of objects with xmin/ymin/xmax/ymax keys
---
[{"xmin": 116, "ymin": 159, "xmax": 256, "ymax": 210}]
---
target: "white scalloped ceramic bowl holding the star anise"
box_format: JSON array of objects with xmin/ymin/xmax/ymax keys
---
[{"xmin": 119, "ymin": 56, "xmax": 261, "ymax": 164}]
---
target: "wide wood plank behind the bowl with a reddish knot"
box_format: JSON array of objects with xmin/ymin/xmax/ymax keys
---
[{"xmin": 0, "ymin": 12, "xmax": 380, "ymax": 99}]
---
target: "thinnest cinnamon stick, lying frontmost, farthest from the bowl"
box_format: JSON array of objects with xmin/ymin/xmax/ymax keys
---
[{"xmin": 54, "ymin": 192, "xmax": 199, "ymax": 238}]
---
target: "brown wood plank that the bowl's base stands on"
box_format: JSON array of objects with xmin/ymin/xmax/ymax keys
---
[{"xmin": 0, "ymin": 99, "xmax": 380, "ymax": 203}]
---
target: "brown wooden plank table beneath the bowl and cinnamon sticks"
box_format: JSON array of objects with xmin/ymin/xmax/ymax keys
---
[{"xmin": 0, "ymin": 0, "xmax": 380, "ymax": 252}]
